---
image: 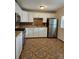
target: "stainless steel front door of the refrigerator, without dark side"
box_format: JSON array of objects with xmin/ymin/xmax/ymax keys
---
[{"xmin": 49, "ymin": 19, "xmax": 57, "ymax": 37}]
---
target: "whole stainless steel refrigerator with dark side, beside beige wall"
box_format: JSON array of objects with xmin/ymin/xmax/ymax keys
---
[{"xmin": 47, "ymin": 18, "xmax": 57, "ymax": 38}]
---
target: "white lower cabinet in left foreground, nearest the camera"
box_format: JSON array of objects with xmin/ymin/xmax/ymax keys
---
[{"xmin": 16, "ymin": 32, "xmax": 22, "ymax": 59}]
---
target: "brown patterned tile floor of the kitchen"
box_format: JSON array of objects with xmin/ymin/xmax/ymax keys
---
[{"xmin": 20, "ymin": 38, "xmax": 64, "ymax": 59}]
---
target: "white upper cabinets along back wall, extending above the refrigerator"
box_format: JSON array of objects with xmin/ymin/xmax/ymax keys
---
[{"xmin": 28, "ymin": 12, "xmax": 55, "ymax": 22}]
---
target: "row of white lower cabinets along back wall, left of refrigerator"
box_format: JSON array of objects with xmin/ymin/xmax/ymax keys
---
[{"xmin": 26, "ymin": 28, "xmax": 47, "ymax": 38}]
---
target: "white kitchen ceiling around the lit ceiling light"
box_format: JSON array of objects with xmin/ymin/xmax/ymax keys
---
[{"xmin": 17, "ymin": 0, "xmax": 64, "ymax": 11}]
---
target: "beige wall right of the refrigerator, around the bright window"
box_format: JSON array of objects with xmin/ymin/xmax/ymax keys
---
[{"xmin": 56, "ymin": 7, "xmax": 64, "ymax": 41}]
